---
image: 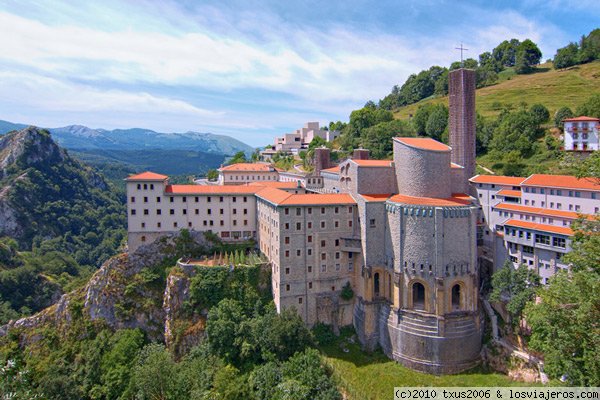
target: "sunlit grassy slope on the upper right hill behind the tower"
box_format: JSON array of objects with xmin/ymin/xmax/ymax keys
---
[{"xmin": 394, "ymin": 61, "xmax": 600, "ymax": 119}]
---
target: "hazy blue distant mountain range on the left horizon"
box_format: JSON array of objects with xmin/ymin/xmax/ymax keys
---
[{"xmin": 0, "ymin": 120, "xmax": 253, "ymax": 155}]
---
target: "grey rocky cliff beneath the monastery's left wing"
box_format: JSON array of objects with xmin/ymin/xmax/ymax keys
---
[{"xmin": 0, "ymin": 233, "xmax": 212, "ymax": 355}]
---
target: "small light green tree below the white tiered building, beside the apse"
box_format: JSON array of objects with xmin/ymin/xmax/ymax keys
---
[{"xmin": 490, "ymin": 261, "xmax": 540, "ymax": 325}]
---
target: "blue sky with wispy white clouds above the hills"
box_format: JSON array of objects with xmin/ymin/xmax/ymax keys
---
[{"xmin": 0, "ymin": 0, "xmax": 600, "ymax": 146}]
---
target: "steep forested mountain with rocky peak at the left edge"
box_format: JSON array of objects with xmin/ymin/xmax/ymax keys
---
[{"xmin": 0, "ymin": 127, "xmax": 126, "ymax": 323}]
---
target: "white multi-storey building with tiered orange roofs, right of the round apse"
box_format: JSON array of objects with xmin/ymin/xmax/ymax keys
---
[{"xmin": 470, "ymin": 174, "xmax": 600, "ymax": 284}]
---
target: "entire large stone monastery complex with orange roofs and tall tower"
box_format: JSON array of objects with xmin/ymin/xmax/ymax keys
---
[{"xmin": 127, "ymin": 69, "xmax": 600, "ymax": 374}]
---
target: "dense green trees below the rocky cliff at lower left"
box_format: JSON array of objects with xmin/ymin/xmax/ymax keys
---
[{"xmin": 0, "ymin": 230, "xmax": 341, "ymax": 400}]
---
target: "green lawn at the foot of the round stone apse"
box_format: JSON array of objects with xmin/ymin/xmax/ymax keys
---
[{"xmin": 320, "ymin": 334, "xmax": 526, "ymax": 400}]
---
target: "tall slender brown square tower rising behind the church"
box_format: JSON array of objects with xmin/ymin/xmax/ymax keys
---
[{"xmin": 448, "ymin": 68, "xmax": 475, "ymax": 186}]
